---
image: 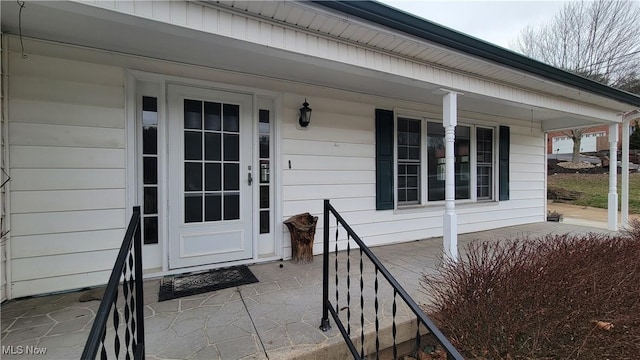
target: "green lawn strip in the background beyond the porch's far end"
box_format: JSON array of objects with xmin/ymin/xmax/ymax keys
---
[{"xmin": 547, "ymin": 174, "xmax": 640, "ymax": 214}]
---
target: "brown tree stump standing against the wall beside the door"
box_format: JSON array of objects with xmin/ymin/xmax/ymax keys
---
[{"xmin": 284, "ymin": 213, "xmax": 318, "ymax": 264}]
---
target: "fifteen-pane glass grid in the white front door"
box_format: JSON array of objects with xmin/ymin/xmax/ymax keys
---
[{"xmin": 184, "ymin": 99, "xmax": 240, "ymax": 223}]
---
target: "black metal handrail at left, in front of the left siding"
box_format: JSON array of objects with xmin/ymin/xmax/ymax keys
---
[{"xmin": 81, "ymin": 206, "xmax": 144, "ymax": 360}]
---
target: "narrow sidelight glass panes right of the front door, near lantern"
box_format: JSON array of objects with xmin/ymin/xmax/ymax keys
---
[{"xmin": 258, "ymin": 109, "xmax": 271, "ymax": 234}]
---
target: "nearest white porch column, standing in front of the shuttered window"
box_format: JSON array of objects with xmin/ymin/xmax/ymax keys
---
[{"xmin": 442, "ymin": 90, "xmax": 458, "ymax": 261}]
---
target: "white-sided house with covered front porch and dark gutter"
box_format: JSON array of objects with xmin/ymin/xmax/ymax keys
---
[{"xmin": 0, "ymin": 1, "xmax": 640, "ymax": 299}]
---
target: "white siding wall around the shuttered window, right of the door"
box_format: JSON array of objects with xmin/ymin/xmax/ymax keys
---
[{"xmin": 282, "ymin": 96, "xmax": 546, "ymax": 257}]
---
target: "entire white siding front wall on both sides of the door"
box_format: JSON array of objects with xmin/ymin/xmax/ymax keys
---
[{"xmin": 3, "ymin": 38, "xmax": 545, "ymax": 297}]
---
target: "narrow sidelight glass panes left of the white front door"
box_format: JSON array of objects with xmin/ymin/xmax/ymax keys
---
[{"xmin": 141, "ymin": 96, "xmax": 158, "ymax": 244}]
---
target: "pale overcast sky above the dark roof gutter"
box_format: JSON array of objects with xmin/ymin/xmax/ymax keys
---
[{"xmin": 378, "ymin": 0, "xmax": 567, "ymax": 48}]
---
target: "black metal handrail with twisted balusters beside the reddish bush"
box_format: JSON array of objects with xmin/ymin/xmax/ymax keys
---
[{"xmin": 320, "ymin": 200, "xmax": 463, "ymax": 360}]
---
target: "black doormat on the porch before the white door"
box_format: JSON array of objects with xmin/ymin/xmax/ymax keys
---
[{"xmin": 158, "ymin": 265, "xmax": 258, "ymax": 301}]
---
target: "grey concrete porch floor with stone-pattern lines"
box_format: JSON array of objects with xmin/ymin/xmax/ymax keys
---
[{"xmin": 0, "ymin": 223, "xmax": 607, "ymax": 360}]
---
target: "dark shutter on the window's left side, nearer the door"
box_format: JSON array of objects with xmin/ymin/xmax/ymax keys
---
[{"xmin": 376, "ymin": 109, "xmax": 393, "ymax": 210}]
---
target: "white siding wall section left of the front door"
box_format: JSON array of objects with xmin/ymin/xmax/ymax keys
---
[{"xmin": 9, "ymin": 52, "xmax": 127, "ymax": 297}]
